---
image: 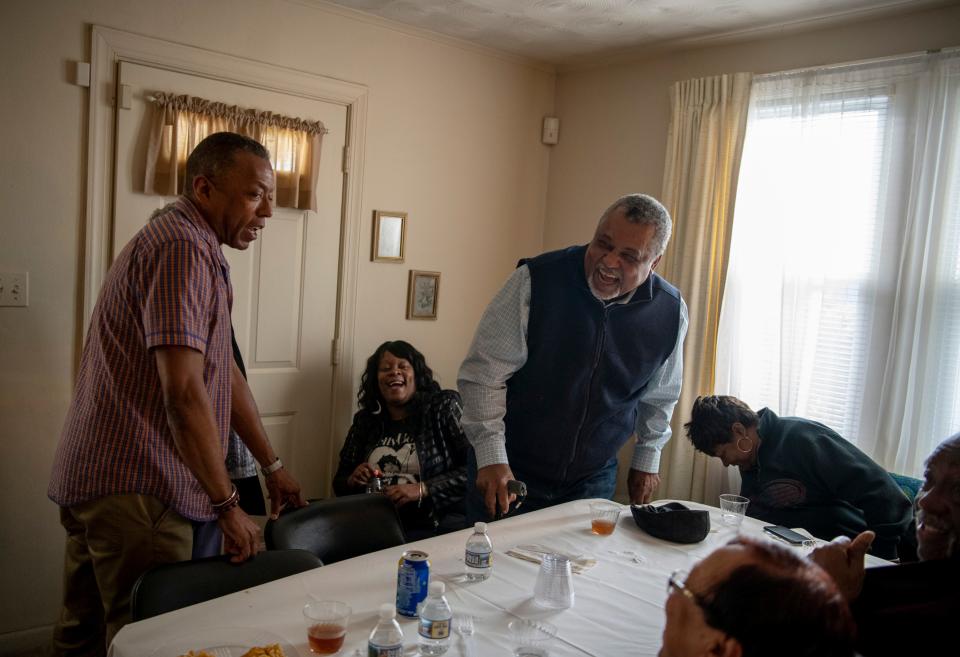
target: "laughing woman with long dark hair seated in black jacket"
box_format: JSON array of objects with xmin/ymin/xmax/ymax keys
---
[{"xmin": 333, "ymin": 340, "xmax": 467, "ymax": 540}]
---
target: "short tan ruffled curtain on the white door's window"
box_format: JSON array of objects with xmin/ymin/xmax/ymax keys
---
[{"xmin": 144, "ymin": 92, "xmax": 326, "ymax": 211}]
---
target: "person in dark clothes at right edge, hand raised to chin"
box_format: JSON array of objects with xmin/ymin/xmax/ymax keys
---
[{"xmin": 810, "ymin": 433, "xmax": 960, "ymax": 657}]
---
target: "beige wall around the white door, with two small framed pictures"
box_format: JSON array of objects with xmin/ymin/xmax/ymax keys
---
[{"xmin": 0, "ymin": 0, "xmax": 554, "ymax": 640}]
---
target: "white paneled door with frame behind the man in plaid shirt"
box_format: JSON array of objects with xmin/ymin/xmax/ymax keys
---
[{"xmin": 113, "ymin": 62, "xmax": 347, "ymax": 497}]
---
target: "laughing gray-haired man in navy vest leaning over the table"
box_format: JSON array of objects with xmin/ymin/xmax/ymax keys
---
[{"xmin": 458, "ymin": 194, "xmax": 687, "ymax": 522}]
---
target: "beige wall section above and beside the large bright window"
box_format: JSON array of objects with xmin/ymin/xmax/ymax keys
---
[{"xmin": 544, "ymin": 5, "xmax": 960, "ymax": 248}]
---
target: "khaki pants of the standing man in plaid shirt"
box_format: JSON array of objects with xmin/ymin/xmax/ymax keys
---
[{"xmin": 53, "ymin": 493, "xmax": 193, "ymax": 656}]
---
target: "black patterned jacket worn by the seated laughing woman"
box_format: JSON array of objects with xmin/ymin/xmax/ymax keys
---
[{"xmin": 333, "ymin": 390, "xmax": 467, "ymax": 526}]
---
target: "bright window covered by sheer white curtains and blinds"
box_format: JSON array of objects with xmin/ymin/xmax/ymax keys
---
[{"xmin": 715, "ymin": 50, "xmax": 960, "ymax": 476}]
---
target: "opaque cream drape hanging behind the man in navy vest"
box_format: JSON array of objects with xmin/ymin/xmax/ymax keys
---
[{"xmin": 657, "ymin": 73, "xmax": 752, "ymax": 504}]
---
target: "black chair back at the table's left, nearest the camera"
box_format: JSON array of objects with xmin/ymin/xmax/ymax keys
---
[{"xmin": 130, "ymin": 550, "xmax": 323, "ymax": 621}]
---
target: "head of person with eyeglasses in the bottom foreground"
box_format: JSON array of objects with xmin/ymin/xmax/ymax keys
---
[{"xmin": 660, "ymin": 537, "xmax": 856, "ymax": 657}]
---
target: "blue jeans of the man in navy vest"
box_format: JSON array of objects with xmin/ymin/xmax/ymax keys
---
[{"xmin": 467, "ymin": 447, "xmax": 617, "ymax": 526}]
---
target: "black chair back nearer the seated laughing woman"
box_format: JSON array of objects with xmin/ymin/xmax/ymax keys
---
[{"xmin": 263, "ymin": 493, "xmax": 406, "ymax": 564}]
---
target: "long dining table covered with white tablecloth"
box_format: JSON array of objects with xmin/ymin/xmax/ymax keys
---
[{"xmin": 109, "ymin": 500, "xmax": 885, "ymax": 657}]
